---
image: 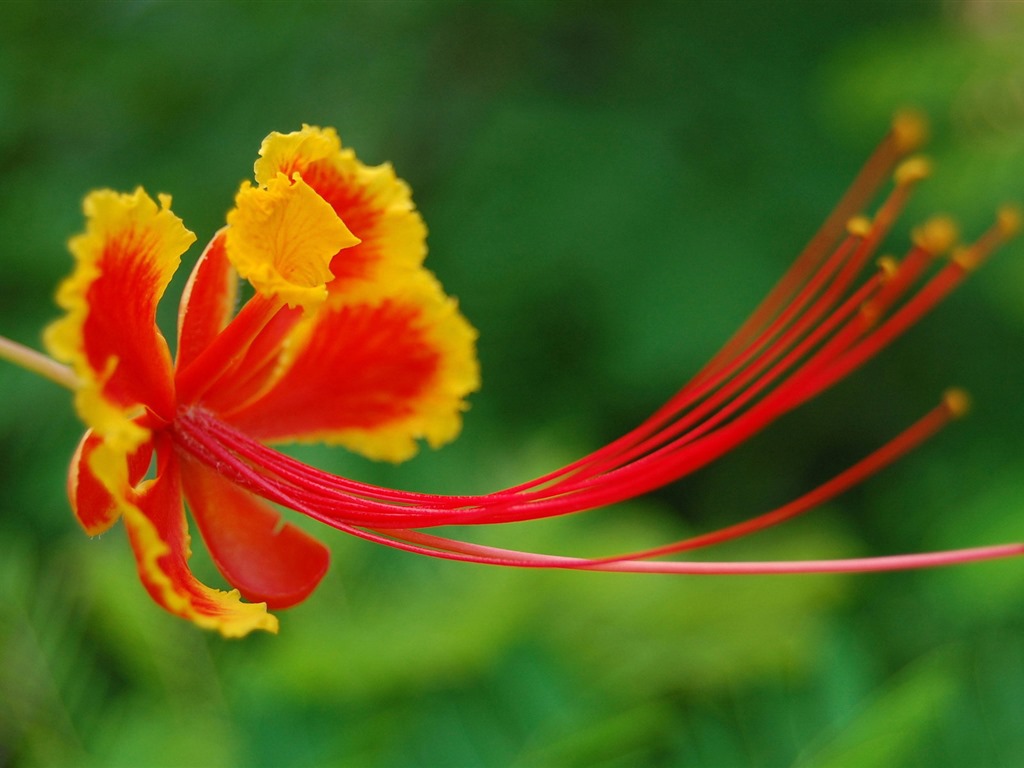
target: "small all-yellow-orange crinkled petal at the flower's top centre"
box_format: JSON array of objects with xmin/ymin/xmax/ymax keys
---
[{"xmin": 226, "ymin": 173, "xmax": 359, "ymax": 307}]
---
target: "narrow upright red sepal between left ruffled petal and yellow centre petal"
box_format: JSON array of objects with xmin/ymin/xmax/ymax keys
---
[{"xmin": 174, "ymin": 229, "xmax": 238, "ymax": 371}]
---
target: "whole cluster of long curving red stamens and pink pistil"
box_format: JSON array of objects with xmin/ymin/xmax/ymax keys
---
[{"xmin": 163, "ymin": 112, "xmax": 1024, "ymax": 573}]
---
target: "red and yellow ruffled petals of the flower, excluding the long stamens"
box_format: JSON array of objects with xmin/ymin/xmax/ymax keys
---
[{"xmin": 39, "ymin": 126, "xmax": 478, "ymax": 635}]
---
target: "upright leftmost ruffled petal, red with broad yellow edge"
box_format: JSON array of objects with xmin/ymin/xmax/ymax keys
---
[{"xmin": 45, "ymin": 188, "xmax": 196, "ymax": 455}]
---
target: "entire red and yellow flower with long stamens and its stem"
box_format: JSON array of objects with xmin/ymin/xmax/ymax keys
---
[{"xmin": 0, "ymin": 114, "xmax": 1024, "ymax": 636}]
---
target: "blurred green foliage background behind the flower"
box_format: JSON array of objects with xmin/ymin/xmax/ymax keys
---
[{"xmin": 0, "ymin": 0, "xmax": 1024, "ymax": 768}]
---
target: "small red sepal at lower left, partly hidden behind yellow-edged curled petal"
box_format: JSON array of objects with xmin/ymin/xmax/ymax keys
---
[{"xmin": 68, "ymin": 429, "xmax": 153, "ymax": 536}]
